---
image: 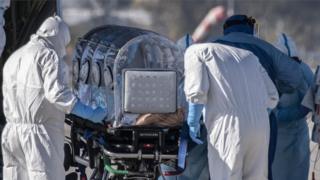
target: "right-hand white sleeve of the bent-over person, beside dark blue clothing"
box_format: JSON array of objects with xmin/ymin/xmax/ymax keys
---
[{"xmin": 259, "ymin": 64, "xmax": 279, "ymax": 109}]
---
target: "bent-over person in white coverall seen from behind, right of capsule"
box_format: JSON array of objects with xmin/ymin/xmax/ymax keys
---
[{"xmin": 185, "ymin": 43, "xmax": 278, "ymax": 180}]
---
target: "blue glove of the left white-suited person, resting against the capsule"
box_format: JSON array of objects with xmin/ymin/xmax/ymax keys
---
[{"xmin": 71, "ymin": 101, "xmax": 107, "ymax": 123}]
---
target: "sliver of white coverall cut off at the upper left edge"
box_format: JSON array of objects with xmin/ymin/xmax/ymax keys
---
[{"xmin": 0, "ymin": 0, "xmax": 10, "ymax": 57}]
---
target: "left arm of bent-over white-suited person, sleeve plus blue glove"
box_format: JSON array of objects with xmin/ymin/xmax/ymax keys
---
[{"xmin": 184, "ymin": 44, "xmax": 212, "ymax": 144}]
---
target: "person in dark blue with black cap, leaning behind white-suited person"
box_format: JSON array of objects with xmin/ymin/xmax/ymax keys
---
[{"xmin": 214, "ymin": 14, "xmax": 307, "ymax": 180}]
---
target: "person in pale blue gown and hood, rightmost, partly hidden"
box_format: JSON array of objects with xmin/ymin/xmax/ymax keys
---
[{"xmin": 272, "ymin": 34, "xmax": 313, "ymax": 180}]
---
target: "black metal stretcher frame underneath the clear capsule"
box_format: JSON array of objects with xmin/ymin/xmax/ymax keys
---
[{"xmin": 66, "ymin": 115, "xmax": 187, "ymax": 179}]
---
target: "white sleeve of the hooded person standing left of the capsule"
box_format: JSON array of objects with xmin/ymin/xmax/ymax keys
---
[{"xmin": 42, "ymin": 51, "xmax": 77, "ymax": 113}]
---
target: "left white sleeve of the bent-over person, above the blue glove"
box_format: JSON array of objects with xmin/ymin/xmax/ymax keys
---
[{"xmin": 184, "ymin": 45, "xmax": 209, "ymax": 104}]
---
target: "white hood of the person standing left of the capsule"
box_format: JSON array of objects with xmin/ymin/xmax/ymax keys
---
[{"xmin": 36, "ymin": 16, "xmax": 70, "ymax": 57}]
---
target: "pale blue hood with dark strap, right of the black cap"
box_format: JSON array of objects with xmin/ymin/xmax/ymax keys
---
[{"xmin": 275, "ymin": 33, "xmax": 299, "ymax": 57}]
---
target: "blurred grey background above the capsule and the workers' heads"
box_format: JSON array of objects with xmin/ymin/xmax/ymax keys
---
[{"xmin": 61, "ymin": 0, "xmax": 320, "ymax": 69}]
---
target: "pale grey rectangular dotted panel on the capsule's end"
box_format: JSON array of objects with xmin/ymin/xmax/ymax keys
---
[{"xmin": 123, "ymin": 70, "xmax": 177, "ymax": 113}]
